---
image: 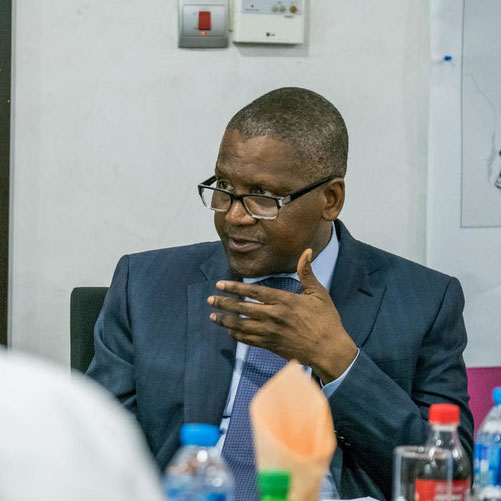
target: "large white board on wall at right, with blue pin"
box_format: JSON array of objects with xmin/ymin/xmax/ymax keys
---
[{"xmin": 427, "ymin": 0, "xmax": 501, "ymax": 366}]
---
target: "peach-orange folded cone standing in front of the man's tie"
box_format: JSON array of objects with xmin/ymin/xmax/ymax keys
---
[{"xmin": 250, "ymin": 361, "xmax": 336, "ymax": 501}]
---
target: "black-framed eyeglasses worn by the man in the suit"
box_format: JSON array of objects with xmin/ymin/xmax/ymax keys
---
[{"xmin": 198, "ymin": 176, "xmax": 334, "ymax": 219}]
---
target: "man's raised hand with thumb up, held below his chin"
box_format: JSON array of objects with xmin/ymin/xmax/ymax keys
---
[{"xmin": 207, "ymin": 249, "xmax": 357, "ymax": 383}]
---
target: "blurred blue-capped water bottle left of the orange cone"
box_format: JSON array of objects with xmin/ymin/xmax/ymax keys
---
[{"xmin": 164, "ymin": 424, "xmax": 234, "ymax": 501}]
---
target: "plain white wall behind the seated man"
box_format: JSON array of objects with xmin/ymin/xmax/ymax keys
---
[{"xmin": 10, "ymin": 0, "xmax": 429, "ymax": 363}]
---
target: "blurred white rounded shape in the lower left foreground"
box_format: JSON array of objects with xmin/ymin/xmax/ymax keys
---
[{"xmin": 0, "ymin": 350, "xmax": 162, "ymax": 501}]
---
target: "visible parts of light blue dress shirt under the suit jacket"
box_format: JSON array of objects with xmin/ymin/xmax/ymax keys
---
[{"xmin": 216, "ymin": 225, "xmax": 358, "ymax": 499}]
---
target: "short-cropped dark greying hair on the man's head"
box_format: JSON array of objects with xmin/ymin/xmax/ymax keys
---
[{"xmin": 227, "ymin": 87, "xmax": 348, "ymax": 180}]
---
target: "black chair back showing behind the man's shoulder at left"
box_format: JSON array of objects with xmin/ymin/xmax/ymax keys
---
[{"xmin": 70, "ymin": 287, "xmax": 108, "ymax": 372}]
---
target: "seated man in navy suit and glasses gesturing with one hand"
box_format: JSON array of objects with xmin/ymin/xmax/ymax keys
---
[{"xmin": 89, "ymin": 88, "xmax": 473, "ymax": 501}]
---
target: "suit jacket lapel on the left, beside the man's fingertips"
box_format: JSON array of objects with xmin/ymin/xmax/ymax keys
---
[{"xmin": 184, "ymin": 249, "xmax": 239, "ymax": 426}]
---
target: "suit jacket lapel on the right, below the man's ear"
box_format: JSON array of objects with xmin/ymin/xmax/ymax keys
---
[{"xmin": 330, "ymin": 221, "xmax": 386, "ymax": 346}]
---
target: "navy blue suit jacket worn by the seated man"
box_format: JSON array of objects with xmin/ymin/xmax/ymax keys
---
[{"xmin": 88, "ymin": 221, "xmax": 473, "ymax": 499}]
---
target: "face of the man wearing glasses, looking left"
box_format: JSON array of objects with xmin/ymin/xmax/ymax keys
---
[{"xmin": 214, "ymin": 129, "xmax": 331, "ymax": 278}]
